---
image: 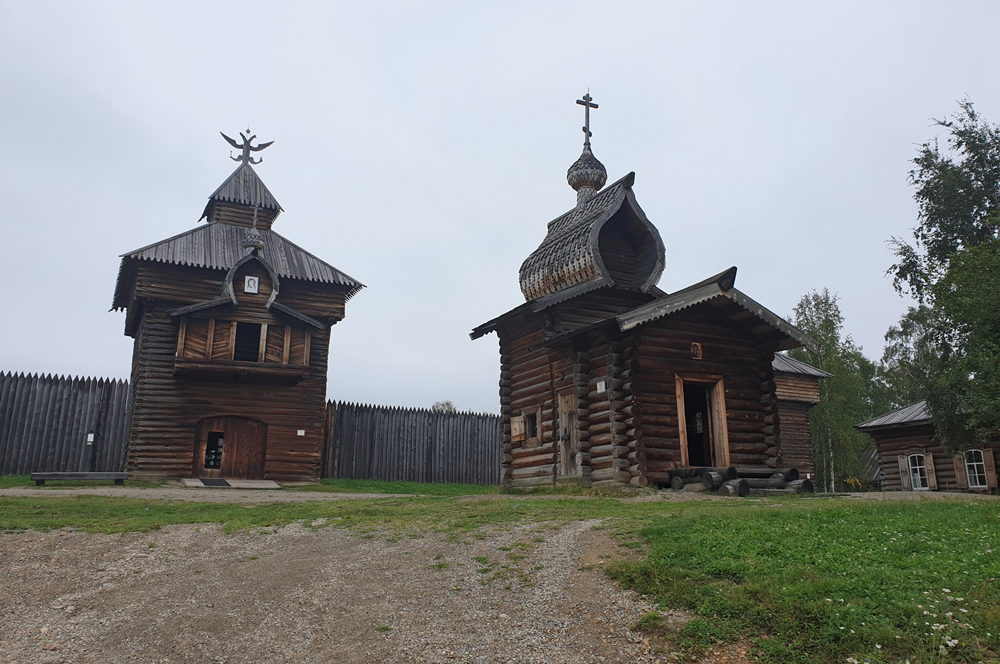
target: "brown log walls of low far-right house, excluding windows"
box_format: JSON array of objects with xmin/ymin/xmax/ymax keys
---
[{"xmin": 868, "ymin": 424, "xmax": 1000, "ymax": 493}]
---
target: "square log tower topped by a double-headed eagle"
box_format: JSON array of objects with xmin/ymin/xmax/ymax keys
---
[{"xmin": 112, "ymin": 130, "xmax": 364, "ymax": 481}]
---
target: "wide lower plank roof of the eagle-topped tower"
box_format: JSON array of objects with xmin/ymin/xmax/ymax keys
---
[{"xmin": 112, "ymin": 223, "xmax": 364, "ymax": 309}]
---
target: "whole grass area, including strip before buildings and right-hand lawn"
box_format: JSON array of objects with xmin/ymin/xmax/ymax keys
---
[{"xmin": 0, "ymin": 482, "xmax": 1000, "ymax": 664}]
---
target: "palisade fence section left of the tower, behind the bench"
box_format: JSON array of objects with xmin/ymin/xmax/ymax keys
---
[{"xmin": 0, "ymin": 373, "xmax": 129, "ymax": 475}]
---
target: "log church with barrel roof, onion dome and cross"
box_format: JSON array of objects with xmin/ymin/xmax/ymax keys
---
[{"xmin": 471, "ymin": 95, "xmax": 813, "ymax": 487}]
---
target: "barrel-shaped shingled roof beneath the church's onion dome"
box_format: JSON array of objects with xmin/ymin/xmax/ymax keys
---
[{"xmin": 519, "ymin": 173, "xmax": 665, "ymax": 311}]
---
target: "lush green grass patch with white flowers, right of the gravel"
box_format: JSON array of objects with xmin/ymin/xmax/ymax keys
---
[{"xmin": 608, "ymin": 500, "xmax": 1000, "ymax": 664}]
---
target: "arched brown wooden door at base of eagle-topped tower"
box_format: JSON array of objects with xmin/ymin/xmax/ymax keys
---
[{"xmin": 192, "ymin": 416, "xmax": 267, "ymax": 480}]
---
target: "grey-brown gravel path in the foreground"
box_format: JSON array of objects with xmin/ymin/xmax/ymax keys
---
[{"xmin": 0, "ymin": 521, "xmax": 708, "ymax": 664}]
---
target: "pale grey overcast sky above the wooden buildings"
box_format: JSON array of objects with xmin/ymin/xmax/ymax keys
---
[{"xmin": 0, "ymin": 0, "xmax": 1000, "ymax": 412}]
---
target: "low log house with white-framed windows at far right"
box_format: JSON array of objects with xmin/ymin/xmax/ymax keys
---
[{"xmin": 855, "ymin": 401, "xmax": 1000, "ymax": 493}]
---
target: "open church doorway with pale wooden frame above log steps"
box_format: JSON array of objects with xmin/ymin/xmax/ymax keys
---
[{"xmin": 676, "ymin": 375, "xmax": 729, "ymax": 467}]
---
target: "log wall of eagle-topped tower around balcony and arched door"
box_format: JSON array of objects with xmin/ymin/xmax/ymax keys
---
[{"xmin": 128, "ymin": 302, "xmax": 330, "ymax": 481}]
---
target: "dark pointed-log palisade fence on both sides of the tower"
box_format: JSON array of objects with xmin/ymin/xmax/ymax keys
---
[{"xmin": 0, "ymin": 373, "xmax": 500, "ymax": 484}]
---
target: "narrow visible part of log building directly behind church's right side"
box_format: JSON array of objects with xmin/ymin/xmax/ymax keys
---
[{"xmin": 771, "ymin": 354, "xmax": 833, "ymax": 479}]
